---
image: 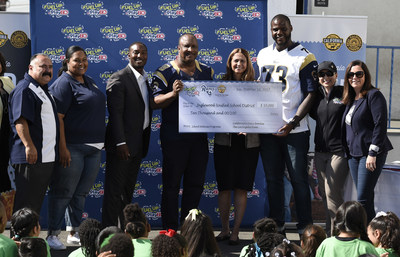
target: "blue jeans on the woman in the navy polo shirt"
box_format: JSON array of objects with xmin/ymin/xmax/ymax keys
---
[{"xmin": 48, "ymin": 144, "xmax": 101, "ymax": 235}]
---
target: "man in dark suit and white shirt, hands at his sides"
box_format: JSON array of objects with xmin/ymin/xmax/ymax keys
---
[{"xmin": 102, "ymin": 42, "xmax": 153, "ymax": 227}]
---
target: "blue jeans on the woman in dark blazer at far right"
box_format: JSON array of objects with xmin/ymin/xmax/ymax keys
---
[{"xmin": 349, "ymin": 152, "xmax": 387, "ymax": 221}]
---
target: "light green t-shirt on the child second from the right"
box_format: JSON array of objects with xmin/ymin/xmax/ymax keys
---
[{"xmin": 316, "ymin": 237, "xmax": 379, "ymax": 257}]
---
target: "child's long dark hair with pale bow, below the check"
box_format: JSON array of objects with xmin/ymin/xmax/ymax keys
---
[{"xmin": 181, "ymin": 209, "xmax": 221, "ymax": 257}]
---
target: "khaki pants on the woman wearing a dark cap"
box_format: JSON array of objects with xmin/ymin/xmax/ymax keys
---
[{"xmin": 314, "ymin": 152, "xmax": 349, "ymax": 236}]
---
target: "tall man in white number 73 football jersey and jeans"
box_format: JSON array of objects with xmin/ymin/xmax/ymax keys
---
[{"xmin": 257, "ymin": 14, "xmax": 318, "ymax": 234}]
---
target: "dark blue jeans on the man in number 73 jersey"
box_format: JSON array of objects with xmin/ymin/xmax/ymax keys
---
[{"xmin": 260, "ymin": 131, "xmax": 313, "ymax": 233}]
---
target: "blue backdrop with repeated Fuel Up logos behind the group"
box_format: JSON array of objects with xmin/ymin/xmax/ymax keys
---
[{"xmin": 30, "ymin": 0, "xmax": 269, "ymax": 227}]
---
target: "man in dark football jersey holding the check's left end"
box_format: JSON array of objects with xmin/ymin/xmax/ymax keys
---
[{"xmin": 152, "ymin": 34, "xmax": 214, "ymax": 229}]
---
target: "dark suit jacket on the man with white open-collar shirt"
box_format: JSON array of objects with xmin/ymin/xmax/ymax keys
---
[{"xmin": 105, "ymin": 66, "xmax": 152, "ymax": 158}]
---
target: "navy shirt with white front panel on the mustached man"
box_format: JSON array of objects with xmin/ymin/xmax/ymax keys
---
[{"xmin": 9, "ymin": 73, "xmax": 59, "ymax": 164}]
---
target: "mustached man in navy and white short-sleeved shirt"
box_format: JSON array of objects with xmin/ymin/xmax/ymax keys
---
[{"xmin": 9, "ymin": 54, "xmax": 59, "ymax": 213}]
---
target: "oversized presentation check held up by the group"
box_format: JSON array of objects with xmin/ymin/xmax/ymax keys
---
[{"xmin": 179, "ymin": 81, "xmax": 284, "ymax": 133}]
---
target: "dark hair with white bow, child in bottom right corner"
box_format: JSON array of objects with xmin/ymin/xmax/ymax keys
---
[{"xmin": 369, "ymin": 211, "xmax": 400, "ymax": 255}]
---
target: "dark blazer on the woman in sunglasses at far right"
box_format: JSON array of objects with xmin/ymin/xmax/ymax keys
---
[{"xmin": 342, "ymin": 89, "xmax": 393, "ymax": 157}]
